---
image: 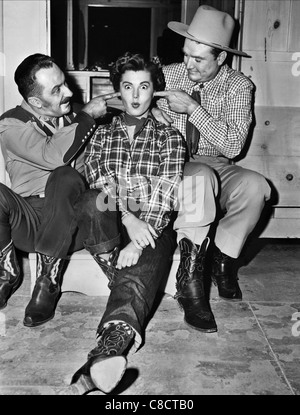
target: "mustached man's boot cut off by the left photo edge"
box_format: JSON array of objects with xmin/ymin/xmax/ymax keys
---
[{"xmin": 0, "ymin": 241, "xmax": 22, "ymax": 310}]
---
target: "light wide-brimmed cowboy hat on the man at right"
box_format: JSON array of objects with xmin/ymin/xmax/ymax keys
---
[{"xmin": 168, "ymin": 5, "xmax": 251, "ymax": 58}]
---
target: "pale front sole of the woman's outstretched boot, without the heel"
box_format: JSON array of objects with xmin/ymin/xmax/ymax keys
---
[{"xmin": 90, "ymin": 356, "xmax": 127, "ymax": 393}]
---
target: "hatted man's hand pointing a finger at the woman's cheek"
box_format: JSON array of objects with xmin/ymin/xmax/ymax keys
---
[{"xmin": 154, "ymin": 89, "xmax": 199, "ymax": 115}]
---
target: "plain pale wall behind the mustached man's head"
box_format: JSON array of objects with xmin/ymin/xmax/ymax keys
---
[{"xmin": 0, "ymin": 0, "xmax": 50, "ymax": 183}]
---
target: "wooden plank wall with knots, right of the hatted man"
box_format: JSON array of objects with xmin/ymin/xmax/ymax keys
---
[{"xmin": 239, "ymin": 0, "xmax": 300, "ymax": 238}]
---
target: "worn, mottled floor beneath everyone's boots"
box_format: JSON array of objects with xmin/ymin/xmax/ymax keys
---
[{"xmin": 0, "ymin": 239, "xmax": 300, "ymax": 395}]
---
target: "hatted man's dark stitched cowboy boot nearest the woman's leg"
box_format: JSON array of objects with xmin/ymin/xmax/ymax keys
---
[{"xmin": 175, "ymin": 238, "xmax": 217, "ymax": 333}]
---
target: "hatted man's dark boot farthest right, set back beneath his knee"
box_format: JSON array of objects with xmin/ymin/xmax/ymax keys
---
[{"xmin": 211, "ymin": 247, "xmax": 242, "ymax": 301}]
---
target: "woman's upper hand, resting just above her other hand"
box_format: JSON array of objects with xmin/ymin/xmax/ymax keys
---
[{"xmin": 122, "ymin": 213, "xmax": 158, "ymax": 249}]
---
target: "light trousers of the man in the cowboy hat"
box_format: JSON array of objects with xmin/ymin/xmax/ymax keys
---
[{"xmin": 174, "ymin": 156, "xmax": 271, "ymax": 258}]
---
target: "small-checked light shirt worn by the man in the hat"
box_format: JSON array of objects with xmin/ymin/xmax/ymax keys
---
[{"xmin": 157, "ymin": 63, "xmax": 253, "ymax": 159}]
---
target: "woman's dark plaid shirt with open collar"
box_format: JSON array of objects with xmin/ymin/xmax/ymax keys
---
[{"xmin": 85, "ymin": 114, "xmax": 185, "ymax": 233}]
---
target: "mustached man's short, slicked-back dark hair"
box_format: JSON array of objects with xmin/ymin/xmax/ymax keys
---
[{"xmin": 15, "ymin": 53, "xmax": 55, "ymax": 101}]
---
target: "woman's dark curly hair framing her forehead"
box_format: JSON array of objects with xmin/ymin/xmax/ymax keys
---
[{"xmin": 110, "ymin": 52, "xmax": 165, "ymax": 92}]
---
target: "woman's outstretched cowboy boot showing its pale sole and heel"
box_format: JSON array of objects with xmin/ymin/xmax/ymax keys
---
[{"xmin": 61, "ymin": 322, "xmax": 135, "ymax": 395}]
